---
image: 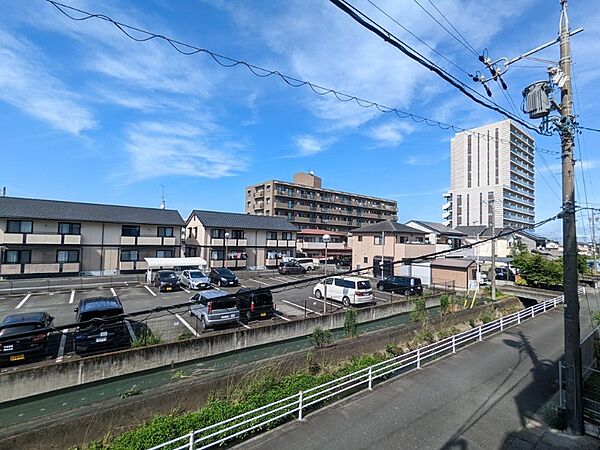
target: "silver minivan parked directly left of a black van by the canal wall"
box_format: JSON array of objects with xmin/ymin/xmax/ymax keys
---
[{"xmin": 190, "ymin": 290, "xmax": 240, "ymax": 331}]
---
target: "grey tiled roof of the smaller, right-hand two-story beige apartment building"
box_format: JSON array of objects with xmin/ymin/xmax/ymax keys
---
[{"xmin": 188, "ymin": 209, "xmax": 298, "ymax": 231}]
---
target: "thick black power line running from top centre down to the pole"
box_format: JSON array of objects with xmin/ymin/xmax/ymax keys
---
[{"xmin": 329, "ymin": 0, "xmax": 542, "ymax": 134}]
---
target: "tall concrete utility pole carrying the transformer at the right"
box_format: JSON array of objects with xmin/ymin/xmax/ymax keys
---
[{"xmin": 559, "ymin": 0, "xmax": 584, "ymax": 435}]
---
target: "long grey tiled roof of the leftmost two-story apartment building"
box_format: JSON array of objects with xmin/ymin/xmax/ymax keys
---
[{"xmin": 0, "ymin": 197, "xmax": 184, "ymax": 226}]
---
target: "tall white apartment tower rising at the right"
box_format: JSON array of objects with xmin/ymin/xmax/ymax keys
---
[{"xmin": 442, "ymin": 120, "xmax": 535, "ymax": 228}]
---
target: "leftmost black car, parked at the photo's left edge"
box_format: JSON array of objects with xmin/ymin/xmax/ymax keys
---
[{"xmin": 0, "ymin": 312, "xmax": 54, "ymax": 363}]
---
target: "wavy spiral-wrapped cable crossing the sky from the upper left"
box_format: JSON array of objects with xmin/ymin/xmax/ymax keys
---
[{"xmin": 46, "ymin": 0, "xmax": 559, "ymax": 154}]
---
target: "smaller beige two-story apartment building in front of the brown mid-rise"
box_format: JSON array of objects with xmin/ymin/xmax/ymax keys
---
[{"xmin": 185, "ymin": 210, "xmax": 298, "ymax": 269}]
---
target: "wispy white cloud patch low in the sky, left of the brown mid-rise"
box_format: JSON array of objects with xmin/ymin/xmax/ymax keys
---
[{"xmin": 119, "ymin": 120, "xmax": 248, "ymax": 184}]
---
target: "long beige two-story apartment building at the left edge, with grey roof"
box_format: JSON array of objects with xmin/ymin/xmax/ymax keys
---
[{"xmin": 0, "ymin": 197, "xmax": 184, "ymax": 278}]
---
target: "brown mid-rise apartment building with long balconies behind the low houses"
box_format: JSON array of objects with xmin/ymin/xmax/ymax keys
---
[{"xmin": 245, "ymin": 172, "xmax": 398, "ymax": 233}]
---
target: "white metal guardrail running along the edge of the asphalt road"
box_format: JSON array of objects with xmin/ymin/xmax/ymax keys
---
[{"xmin": 149, "ymin": 295, "xmax": 563, "ymax": 450}]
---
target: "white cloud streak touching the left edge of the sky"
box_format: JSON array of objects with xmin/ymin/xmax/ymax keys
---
[{"xmin": 0, "ymin": 29, "xmax": 95, "ymax": 134}]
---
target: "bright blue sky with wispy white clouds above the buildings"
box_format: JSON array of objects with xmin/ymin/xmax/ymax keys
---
[{"xmin": 0, "ymin": 0, "xmax": 600, "ymax": 241}]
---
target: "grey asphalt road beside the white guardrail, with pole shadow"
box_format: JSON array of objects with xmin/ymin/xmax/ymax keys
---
[{"xmin": 238, "ymin": 310, "xmax": 580, "ymax": 450}]
